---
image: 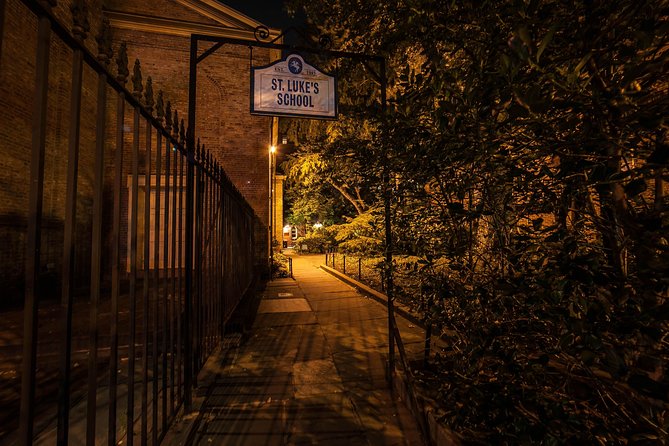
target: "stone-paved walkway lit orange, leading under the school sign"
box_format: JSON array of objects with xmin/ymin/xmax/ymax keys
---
[{"xmin": 184, "ymin": 256, "xmax": 423, "ymax": 446}]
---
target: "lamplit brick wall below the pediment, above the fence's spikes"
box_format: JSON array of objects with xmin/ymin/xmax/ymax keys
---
[{"xmin": 114, "ymin": 30, "xmax": 270, "ymax": 272}]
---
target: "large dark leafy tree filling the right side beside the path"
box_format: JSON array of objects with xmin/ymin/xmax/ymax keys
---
[{"xmin": 284, "ymin": 0, "xmax": 669, "ymax": 443}]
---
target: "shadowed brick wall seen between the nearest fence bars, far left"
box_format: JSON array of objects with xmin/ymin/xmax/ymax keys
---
[{"xmin": 0, "ymin": 0, "xmax": 99, "ymax": 299}]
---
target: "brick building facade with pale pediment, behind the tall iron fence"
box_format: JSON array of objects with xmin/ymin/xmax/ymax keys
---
[{"xmin": 0, "ymin": 0, "xmax": 279, "ymax": 301}]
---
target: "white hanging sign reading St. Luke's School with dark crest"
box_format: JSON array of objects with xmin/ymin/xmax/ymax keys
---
[{"xmin": 251, "ymin": 54, "xmax": 337, "ymax": 119}]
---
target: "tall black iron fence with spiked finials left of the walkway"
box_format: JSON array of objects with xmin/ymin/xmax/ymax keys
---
[{"xmin": 0, "ymin": 0, "xmax": 257, "ymax": 445}]
